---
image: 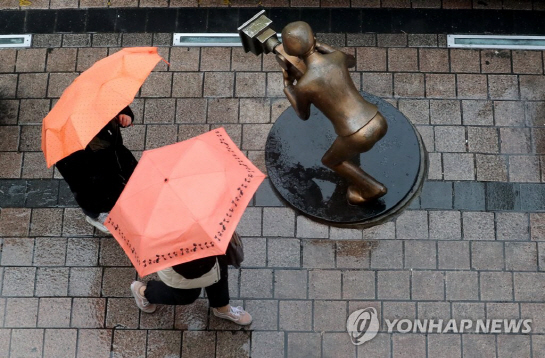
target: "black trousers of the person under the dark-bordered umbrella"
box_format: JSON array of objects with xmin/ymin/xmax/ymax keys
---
[{"xmin": 144, "ymin": 262, "xmax": 229, "ymax": 308}]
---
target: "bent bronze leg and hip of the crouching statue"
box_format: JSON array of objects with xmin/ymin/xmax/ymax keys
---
[{"xmin": 322, "ymin": 114, "xmax": 387, "ymax": 204}]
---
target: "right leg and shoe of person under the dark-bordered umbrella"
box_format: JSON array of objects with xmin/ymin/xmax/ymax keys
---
[{"xmin": 205, "ymin": 264, "xmax": 252, "ymax": 326}]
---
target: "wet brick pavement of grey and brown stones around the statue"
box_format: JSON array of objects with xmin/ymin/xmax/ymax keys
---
[{"xmin": 0, "ymin": 11, "xmax": 545, "ymax": 358}]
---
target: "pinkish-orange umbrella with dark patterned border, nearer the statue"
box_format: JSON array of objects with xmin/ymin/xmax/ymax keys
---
[{"xmin": 105, "ymin": 128, "xmax": 265, "ymax": 276}]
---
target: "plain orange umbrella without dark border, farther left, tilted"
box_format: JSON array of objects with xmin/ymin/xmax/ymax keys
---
[{"xmin": 42, "ymin": 47, "xmax": 162, "ymax": 167}]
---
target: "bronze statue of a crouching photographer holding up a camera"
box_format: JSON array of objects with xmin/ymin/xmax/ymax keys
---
[{"xmin": 239, "ymin": 11, "xmax": 388, "ymax": 204}]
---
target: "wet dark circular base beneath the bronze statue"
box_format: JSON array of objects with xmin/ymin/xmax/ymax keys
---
[{"xmin": 265, "ymin": 93, "xmax": 427, "ymax": 226}]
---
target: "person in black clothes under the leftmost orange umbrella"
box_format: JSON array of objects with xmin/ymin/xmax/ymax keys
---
[{"xmin": 56, "ymin": 106, "xmax": 138, "ymax": 234}]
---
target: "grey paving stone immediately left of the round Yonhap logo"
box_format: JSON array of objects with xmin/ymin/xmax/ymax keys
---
[{"xmin": 314, "ymin": 300, "xmax": 347, "ymax": 332}]
